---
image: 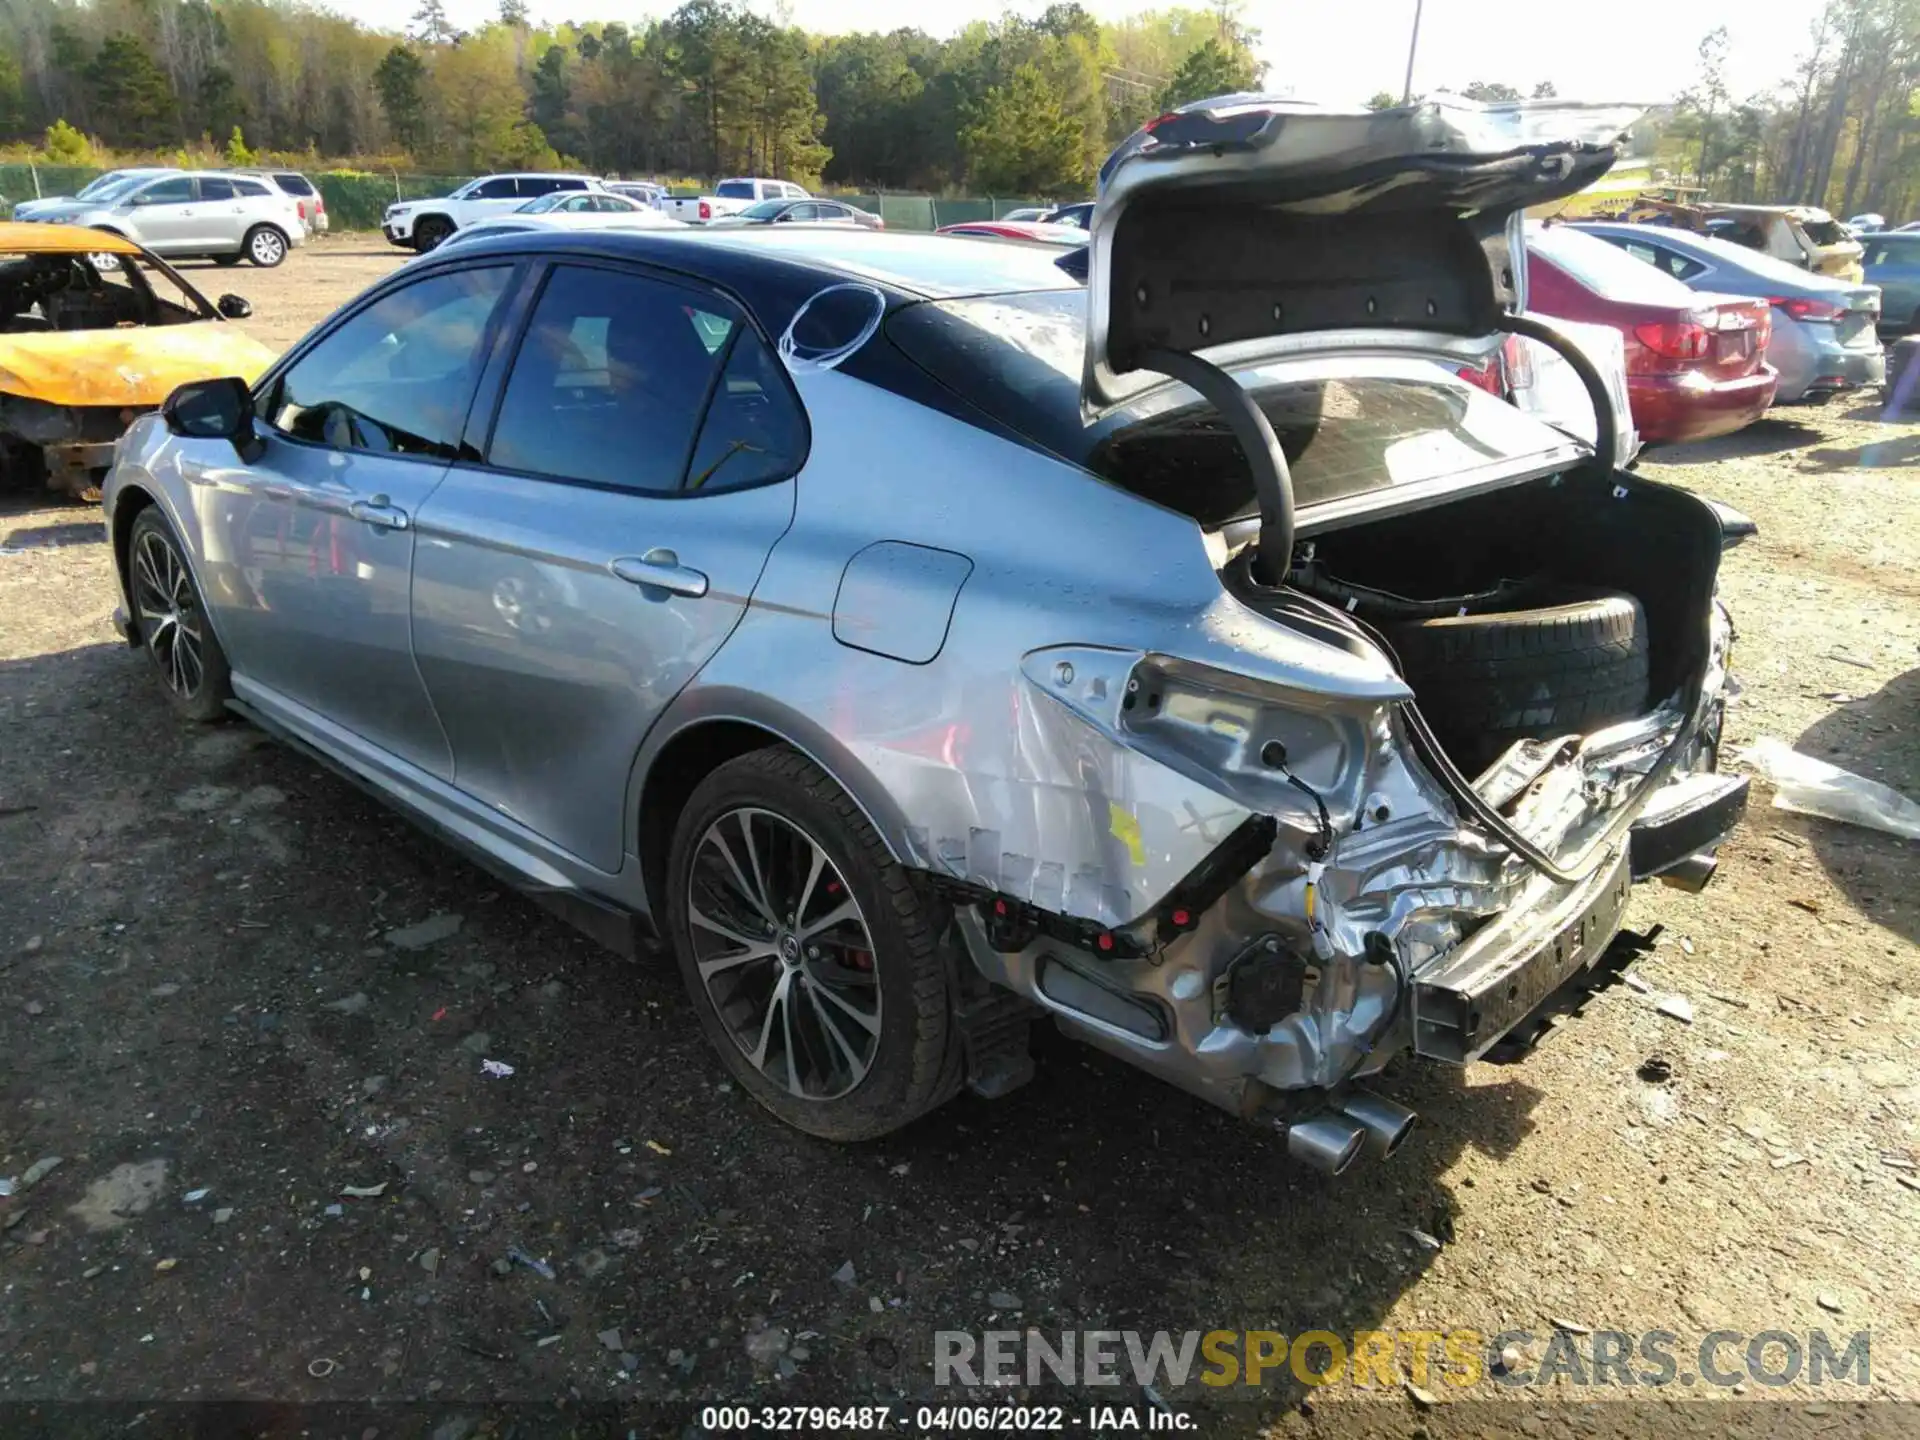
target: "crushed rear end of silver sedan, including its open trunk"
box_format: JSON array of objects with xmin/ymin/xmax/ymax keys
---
[{"xmin": 889, "ymin": 100, "xmax": 1745, "ymax": 1171}]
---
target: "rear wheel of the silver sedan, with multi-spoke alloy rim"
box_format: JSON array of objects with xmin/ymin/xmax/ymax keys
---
[{"xmin": 666, "ymin": 747, "xmax": 958, "ymax": 1140}]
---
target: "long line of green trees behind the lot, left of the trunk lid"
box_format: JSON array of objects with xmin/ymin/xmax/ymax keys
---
[{"xmin": 0, "ymin": 0, "xmax": 1261, "ymax": 194}]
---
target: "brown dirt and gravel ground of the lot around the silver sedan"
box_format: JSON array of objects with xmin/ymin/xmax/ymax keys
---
[{"xmin": 0, "ymin": 238, "xmax": 1920, "ymax": 1434}]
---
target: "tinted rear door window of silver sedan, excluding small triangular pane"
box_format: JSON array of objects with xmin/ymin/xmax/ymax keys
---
[{"xmin": 488, "ymin": 265, "xmax": 768, "ymax": 493}]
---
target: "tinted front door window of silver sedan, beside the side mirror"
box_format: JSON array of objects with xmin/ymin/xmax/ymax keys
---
[{"xmin": 267, "ymin": 265, "xmax": 513, "ymax": 459}]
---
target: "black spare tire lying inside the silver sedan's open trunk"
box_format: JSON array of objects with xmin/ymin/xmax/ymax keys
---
[{"xmin": 1386, "ymin": 593, "xmax": 1647, "ymax": 776}]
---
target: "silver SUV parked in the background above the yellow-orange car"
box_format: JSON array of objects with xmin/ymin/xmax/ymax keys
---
[{"xmin": 21, "ymin": 171, "xmax": 307, "ymax": 269}]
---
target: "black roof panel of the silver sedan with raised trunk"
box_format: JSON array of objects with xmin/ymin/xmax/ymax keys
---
[{"xmin": 441, "ymin": 225, "xmax": 1079, "ymax": 301}]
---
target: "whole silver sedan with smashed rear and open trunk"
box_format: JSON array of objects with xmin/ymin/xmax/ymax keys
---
[{"xmin": 108, "ymin": 98, "xmax": 1747, "ymax": 1173}]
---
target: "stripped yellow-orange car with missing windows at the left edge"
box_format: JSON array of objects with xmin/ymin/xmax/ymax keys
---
[{"xmin": 0, "ymin": 225, "xmax": 273, "ymax": 499}]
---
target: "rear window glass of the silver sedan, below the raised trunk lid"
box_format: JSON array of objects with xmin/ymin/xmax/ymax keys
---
[{"xmin": 887, "ymin": 284, "xmax": 1574, "ymax": 526}]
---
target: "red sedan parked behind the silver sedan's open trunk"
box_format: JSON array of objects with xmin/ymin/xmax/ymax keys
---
[{"xmin": 1526, "ymin": 225, "xmax": 1778, "ymax": 444}]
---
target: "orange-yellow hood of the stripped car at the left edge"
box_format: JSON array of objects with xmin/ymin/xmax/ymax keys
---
[{"xmin": 0, "ymin": 321, "xmax": 273, "ymax": 409}]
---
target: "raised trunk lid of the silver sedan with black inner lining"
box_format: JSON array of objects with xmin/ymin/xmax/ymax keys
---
[{"xmin": 1081, "ymin": 96, "xmax": 1640, "ymax": 419}]
